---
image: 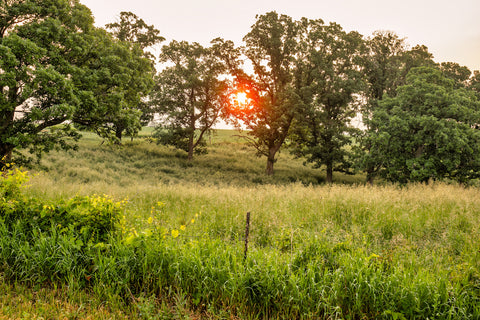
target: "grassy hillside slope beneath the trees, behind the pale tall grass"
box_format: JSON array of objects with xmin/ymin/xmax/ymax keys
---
[{"xmin": 31, "ymin": 128, "xmax": 364, "ymax": 191}]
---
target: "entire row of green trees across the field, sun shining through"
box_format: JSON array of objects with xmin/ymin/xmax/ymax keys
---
[{"xmin": 0, "ymin": 0, "xmax": 480, "ymax": 183}]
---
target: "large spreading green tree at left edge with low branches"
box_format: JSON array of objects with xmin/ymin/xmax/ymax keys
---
[{"xmin": 0, "ymin": 0, "xmax": 154, "ymax": 165}]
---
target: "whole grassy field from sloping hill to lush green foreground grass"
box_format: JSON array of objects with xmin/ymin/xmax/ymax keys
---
[{"xmin": 0, "ymin": 131, "xmax": 480, "ymax": 319}]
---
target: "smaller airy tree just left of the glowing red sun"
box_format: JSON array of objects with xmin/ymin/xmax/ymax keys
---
[{"xmin": 154, "ymin": 41, "xmax": 229, "ymax": 160}]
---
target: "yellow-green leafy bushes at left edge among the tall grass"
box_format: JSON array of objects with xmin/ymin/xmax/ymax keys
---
[{"xmin": 0, "ymin": 169, "xmax": 125, "ymax": 244}]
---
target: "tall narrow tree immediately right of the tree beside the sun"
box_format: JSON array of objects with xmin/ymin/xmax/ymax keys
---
[{"xmin": 293, "ymin": 20, "xmax": 364, "ymax": 183}]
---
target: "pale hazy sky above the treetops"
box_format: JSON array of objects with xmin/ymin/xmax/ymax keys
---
[{"xmin": 80, "ymin": 0, "xmax": 480, "ymax": 71}]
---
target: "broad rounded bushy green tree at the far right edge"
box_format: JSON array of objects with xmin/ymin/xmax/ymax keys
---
[{"xmin": 368, "ymin": 67, "xmax": 480, "ymax": 183}]
